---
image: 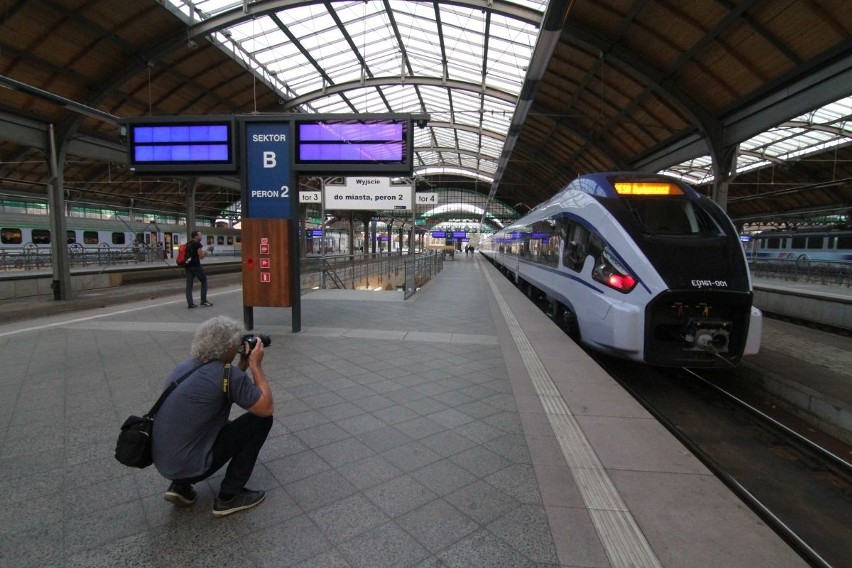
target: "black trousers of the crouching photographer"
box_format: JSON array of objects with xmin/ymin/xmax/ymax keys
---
[{"xmin": 174, "ymin": 412, "xmax": 272, "ymax": 498}]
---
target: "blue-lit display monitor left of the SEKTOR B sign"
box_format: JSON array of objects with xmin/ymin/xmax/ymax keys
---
[{"xmin": 126, "ymin": 116, "xmax": 237, "ymax": 174}]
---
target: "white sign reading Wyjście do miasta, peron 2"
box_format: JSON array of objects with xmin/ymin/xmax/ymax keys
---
[{"xmin": 324, "ymin": 177, "xmax": 411, "ymax": 211}]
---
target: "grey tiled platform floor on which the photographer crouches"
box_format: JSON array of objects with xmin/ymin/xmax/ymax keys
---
[{"xmin": 0, "ymin": 257, "xmax": 806, "ymax": 568}]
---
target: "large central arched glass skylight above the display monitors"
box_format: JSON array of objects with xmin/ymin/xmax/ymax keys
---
[{"xmin": 165, "ymin": 0, "xmax": 547, "ymax": 183}]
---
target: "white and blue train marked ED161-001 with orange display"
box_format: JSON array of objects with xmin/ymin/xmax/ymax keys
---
[{"xmin": 480, "ymin": 172, "xmax": 762, "ymax": 367}]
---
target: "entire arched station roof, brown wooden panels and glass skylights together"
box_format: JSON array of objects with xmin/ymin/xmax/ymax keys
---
[{"xmin": 0, "ymin": 0, "xmax": 852, "ymax": 226}]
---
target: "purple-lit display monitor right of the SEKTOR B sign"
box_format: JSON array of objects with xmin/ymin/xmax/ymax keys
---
[{"xmin": 294, "ymin": 114, "xmax": 413, "ymax": 175}]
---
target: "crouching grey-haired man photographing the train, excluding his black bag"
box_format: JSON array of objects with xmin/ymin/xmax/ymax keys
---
[{"xmin": 152, "ymin": 316, "xmax": 273, "ymax": 517}]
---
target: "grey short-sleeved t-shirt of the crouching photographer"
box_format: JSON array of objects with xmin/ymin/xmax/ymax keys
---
[{"xmin": 152, "ymin": 359, "xmax": 262, "ymax": 479}]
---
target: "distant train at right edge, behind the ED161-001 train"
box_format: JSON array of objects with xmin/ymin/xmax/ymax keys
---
[{"xmin": 743, "ymin": 229, "xmax": 852, "ymax": 268}]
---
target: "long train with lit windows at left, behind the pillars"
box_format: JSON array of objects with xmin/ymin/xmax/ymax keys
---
[{"xmin": 0, "ymin": 213, "xmax": 241, "ymax": 257}]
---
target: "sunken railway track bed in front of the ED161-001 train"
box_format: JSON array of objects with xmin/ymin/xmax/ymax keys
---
[{"xmin": 590, "ymin": 353, "xmax": 852, "ymax": 568}]
